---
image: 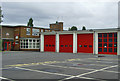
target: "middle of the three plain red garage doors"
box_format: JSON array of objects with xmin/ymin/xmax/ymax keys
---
[{"xmin": 59, "ymin": 34, "xmax": 73, "ymax": 53}]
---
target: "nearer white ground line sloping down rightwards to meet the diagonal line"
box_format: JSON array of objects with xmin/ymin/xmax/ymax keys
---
[{"xmin": 15, "ymin": 67, "xmax": 75, "ymax": 77}]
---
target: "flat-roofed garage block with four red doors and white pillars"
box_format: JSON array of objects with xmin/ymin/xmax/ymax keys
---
[{"xmin": 40, "ymin": 28, "xmax": 120, "ymax": 55}]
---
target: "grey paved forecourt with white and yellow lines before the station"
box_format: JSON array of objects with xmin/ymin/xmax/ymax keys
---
[{"xmin": 0, "ymin": 51, "xmax": 120, "ymax": 81}]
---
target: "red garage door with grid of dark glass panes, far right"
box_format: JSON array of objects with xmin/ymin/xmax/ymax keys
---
[{"xmin": 98, "ymin": 33, "xmax": 117, "ymax": 55}]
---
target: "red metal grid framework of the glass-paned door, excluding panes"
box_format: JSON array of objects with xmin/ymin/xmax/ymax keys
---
[{"xmin": 98, "ymin": 33, "xmax": 117, "ymax": 55}]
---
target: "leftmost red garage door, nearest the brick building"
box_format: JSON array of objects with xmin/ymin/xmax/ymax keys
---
[{"xmin": 44, "ymin": 35, "xmax": 55, "ymax": 52}]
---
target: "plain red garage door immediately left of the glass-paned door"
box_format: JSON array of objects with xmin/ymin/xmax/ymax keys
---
[{"xmin": 77, "ymin": 34, "xmax": 93, "ymax": 53}]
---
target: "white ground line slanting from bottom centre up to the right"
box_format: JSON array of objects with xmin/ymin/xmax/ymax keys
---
[{"xmin": 61, "ymin": 65, "xmax": 118, "ymax": 81}]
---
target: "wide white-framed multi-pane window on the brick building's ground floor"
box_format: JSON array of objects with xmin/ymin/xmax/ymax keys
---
[{"xmin": 20, "ymin": 39, "xmax": 40, "ymax": 49}]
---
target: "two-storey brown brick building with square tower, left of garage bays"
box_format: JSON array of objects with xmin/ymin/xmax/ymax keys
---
[{"xmin": 2, "ymin": 22, "xmax": 63, "ymax": 51}]
